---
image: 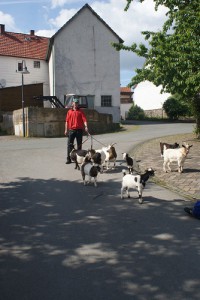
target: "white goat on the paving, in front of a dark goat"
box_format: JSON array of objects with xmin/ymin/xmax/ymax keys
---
[{"xmin": 163, "ymin": 143, "xmax": 192, "ymax": 173}]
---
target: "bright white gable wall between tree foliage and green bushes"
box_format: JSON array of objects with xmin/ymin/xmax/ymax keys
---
[{"xmin": 134, "ymin": 81, "xmax": 170, "ymax": 110}]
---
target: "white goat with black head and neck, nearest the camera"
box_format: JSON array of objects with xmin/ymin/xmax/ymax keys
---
[{"xmin": 121, "ymin": 168, "xmax": 154, "ymax": 204}]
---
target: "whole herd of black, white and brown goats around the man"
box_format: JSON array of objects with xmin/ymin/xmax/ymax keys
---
[{"xmin": 70, "ymin": 142, "xmax": 192, "ymax": 204}]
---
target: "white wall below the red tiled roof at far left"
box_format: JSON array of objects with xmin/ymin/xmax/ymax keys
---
[{"xmin": 0, "ymin": 56, "xmax": 49, "ymax": 95}]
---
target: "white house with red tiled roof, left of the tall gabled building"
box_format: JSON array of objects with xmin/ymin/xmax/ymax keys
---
[{"xmin": 0, "ymin": 24, "xmax": 49, "ymax": 95}]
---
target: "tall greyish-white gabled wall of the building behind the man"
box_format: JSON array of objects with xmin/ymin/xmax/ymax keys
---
[{"xmin": 51, "ymin": 9, "xmax": 120, "ymax": 123}]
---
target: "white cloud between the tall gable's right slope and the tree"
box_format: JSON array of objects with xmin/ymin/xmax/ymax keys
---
[{"xmin": 91, "ymin": 0, "xmax": 167, "ymax": 45}]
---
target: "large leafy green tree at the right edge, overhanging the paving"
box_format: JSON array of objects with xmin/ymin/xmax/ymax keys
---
[{"xmin": 114, "ymin": 0, "xmax": 200, "ymax": 138}]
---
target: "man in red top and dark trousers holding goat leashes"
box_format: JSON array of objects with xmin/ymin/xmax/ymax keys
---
[{"xmin": 65, "ymin": 98, "xmax": 89, "ymax": 164}]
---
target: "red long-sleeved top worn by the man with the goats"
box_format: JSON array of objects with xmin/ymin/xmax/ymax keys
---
[{"xmin": 66, "ymin": 108, "xmax": 87, "ymax": 130}]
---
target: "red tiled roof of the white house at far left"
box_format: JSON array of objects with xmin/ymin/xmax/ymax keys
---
[{"xmin": 0, "ymin": 31, "xmax": 49, "ymax": 60}]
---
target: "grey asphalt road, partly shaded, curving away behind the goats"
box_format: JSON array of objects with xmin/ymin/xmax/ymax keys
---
[{"xmin": 0, "ymin": 123, "xmax": 200, "ymax": 300}]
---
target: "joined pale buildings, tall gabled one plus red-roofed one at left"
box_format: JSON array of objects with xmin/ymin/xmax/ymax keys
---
[{"xmin": 0, "ymin": 4, "xmax": 123, "ymax": 123}]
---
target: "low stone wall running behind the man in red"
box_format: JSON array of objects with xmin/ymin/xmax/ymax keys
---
[{"xmin": 5, "ymin": 107, "xmax": 120, "ymax": 137}]
